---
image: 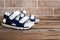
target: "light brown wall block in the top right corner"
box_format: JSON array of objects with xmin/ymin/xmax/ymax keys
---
[{"xmin": 38, "ymin": 0, "xmax": 60, "ymax": 8}]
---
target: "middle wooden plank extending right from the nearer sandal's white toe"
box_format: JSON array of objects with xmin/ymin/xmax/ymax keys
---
[{"xmin": 33, "ymin": 20, "xmax": 60, "ymax": 28}]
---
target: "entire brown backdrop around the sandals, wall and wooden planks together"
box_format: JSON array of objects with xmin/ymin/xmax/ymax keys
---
[{"xmin": 0, "ymin": 0, "xmax": 60, "ymax": 40}]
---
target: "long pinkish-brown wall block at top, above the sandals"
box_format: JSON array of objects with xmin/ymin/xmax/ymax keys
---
[{"xmin": 5, "ymin": 0, "xmax": 37, "ymax": 7}]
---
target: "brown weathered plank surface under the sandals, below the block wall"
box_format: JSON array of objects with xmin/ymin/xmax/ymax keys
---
[{"xmin": 0, "ymin": 16, "xmax": 60, "ymax": 40}]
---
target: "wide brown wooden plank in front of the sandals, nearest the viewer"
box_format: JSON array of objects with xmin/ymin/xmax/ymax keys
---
[{"xmin": 0, "ymin": 29, "xmax": 60, "ymax": 40}]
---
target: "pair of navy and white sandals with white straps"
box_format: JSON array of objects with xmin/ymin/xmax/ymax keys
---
[{"xmin": 2, "ymin": 10, "xmax": 39, "ymax": 29}]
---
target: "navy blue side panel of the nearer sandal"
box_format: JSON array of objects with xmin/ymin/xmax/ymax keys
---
[{"xmin": 4, "ymin": 15, "xmax": 25, "ymax": 27}]
